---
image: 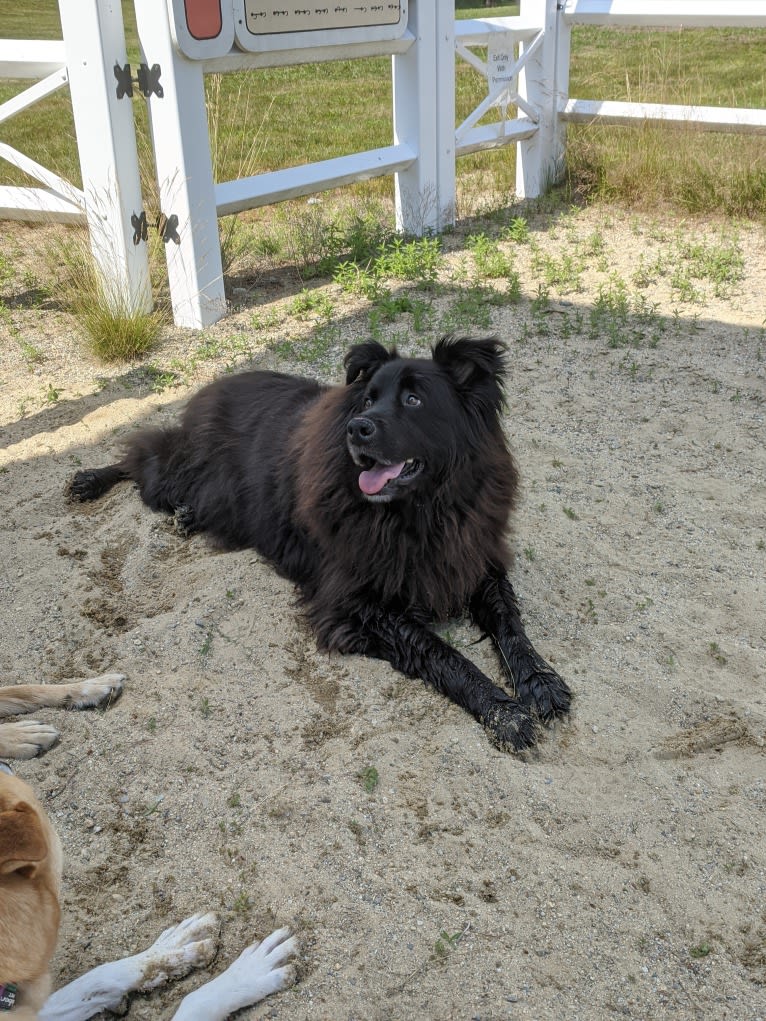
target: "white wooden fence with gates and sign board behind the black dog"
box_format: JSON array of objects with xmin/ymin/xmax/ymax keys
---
[{"xmin": 0, "ymin": 0, "xmax": 766, "ymax": 328}]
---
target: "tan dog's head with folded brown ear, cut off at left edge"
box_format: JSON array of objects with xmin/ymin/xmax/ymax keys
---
[{"xmin": 0, "ymin": 773, "xmax": 61, "ymax": 1021}]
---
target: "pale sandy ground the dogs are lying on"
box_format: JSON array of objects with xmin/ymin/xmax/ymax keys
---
[{"xmin": 0, "ymin": 203, "xmax": 766, "ymax": 1021}]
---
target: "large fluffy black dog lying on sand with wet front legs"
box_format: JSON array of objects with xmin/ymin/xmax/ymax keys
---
[{"xmin": 68, "ymin": 338, "xmax": 571, "ymax": 749}]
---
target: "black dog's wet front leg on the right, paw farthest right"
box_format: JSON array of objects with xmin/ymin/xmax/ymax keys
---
[{"xmin": 471, "ymin": 568, "xmax": 572, "ymax": 723}]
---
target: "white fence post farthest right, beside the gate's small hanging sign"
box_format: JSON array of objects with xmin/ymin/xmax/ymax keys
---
[{"xmin": 516, "ymin": 0, "xmax": 570, "ymax": 198}]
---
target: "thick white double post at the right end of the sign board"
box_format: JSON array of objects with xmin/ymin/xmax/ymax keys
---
[{"xmin": 391, "ymin": 0, "xmax": 454, "ymax": 236}]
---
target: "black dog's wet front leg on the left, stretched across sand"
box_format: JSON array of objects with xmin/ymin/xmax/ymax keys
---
[{"xmin": 346, "ymin": 610, "xmax": 536, "ymax": 751}]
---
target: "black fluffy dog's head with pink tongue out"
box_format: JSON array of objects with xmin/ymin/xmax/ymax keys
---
[{"xmin": 345, "ymin": 337, "xmax": 506, "ymax": 503}]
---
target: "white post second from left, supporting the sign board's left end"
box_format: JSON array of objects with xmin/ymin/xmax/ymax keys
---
[{"xmin": 132, "ymin": 0, "xmax": 226, "ymax": 330}]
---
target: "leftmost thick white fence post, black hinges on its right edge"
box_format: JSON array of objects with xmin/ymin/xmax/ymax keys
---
[{"xmin": 59, "ymin": 0, "xmax": 152, "ymax": 314}]
